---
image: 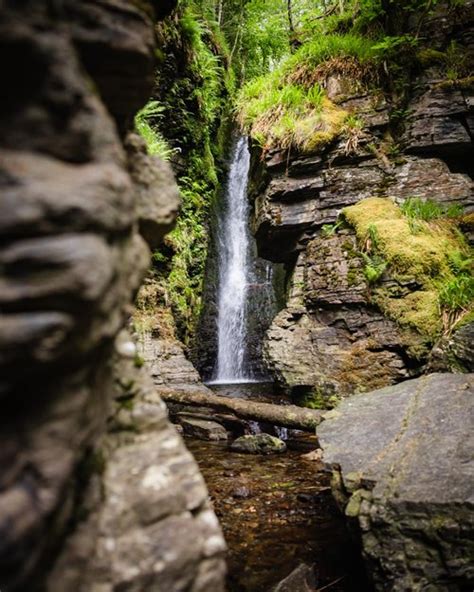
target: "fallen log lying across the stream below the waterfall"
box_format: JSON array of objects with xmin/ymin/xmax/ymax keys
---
[{"xmin": 158, "ymin": 387, "xmax": 323, "ymax": 432}]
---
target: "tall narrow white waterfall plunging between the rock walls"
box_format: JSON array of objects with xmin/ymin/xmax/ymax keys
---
[{"xmin": 214, "ymin": 138, "xmax": 251, "ymax": 382}]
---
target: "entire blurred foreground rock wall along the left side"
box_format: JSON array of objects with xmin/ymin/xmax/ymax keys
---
[{"xmin": 0, "ymin": 0, "xmax": 223, "ymax": 592}]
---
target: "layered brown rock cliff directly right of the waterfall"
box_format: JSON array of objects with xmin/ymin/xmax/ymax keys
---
[{"xmin": 253, "ymin": 2, "xmax": 474, "ymax": 405}]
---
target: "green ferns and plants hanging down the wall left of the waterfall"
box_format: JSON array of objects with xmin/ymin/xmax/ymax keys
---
[{"xmin": 141, "ymin": 0, "xmax": 235, "ymax": 344}]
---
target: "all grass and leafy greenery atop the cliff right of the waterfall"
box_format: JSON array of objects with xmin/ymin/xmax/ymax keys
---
[{"xmin": 237, "ymin": 0, "xmax": 469, "ymax": 153}]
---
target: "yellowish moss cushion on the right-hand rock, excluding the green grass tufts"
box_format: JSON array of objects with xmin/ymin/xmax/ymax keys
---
[{"xmin": 342, "ymin": 197, "xmax": 466, "ymax": 340}]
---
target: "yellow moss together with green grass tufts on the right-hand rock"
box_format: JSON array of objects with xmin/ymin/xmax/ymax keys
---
[{"xmin": 343, "ymin": 197, "xmax": 474, "ymax": 342}]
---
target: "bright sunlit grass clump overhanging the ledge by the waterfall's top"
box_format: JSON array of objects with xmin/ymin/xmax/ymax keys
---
[{"xmin": 237, "ymin": 34, "xmax": 376, "ymax": 152}]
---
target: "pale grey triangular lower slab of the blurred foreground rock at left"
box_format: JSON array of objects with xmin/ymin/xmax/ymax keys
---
[{"xmin": 47, "ymin": 358, "xmax": 226, "ymax": 592}]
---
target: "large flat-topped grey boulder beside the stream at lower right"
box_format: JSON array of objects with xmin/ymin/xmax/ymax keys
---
[{"xmin": 317, "ymin": 374, "xmax": 474, "ymax": 592}]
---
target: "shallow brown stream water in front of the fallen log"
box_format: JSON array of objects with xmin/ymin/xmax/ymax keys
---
[{"xmin": 187, "ymin": 436, "xmax": 370, "ymax": 592}]
